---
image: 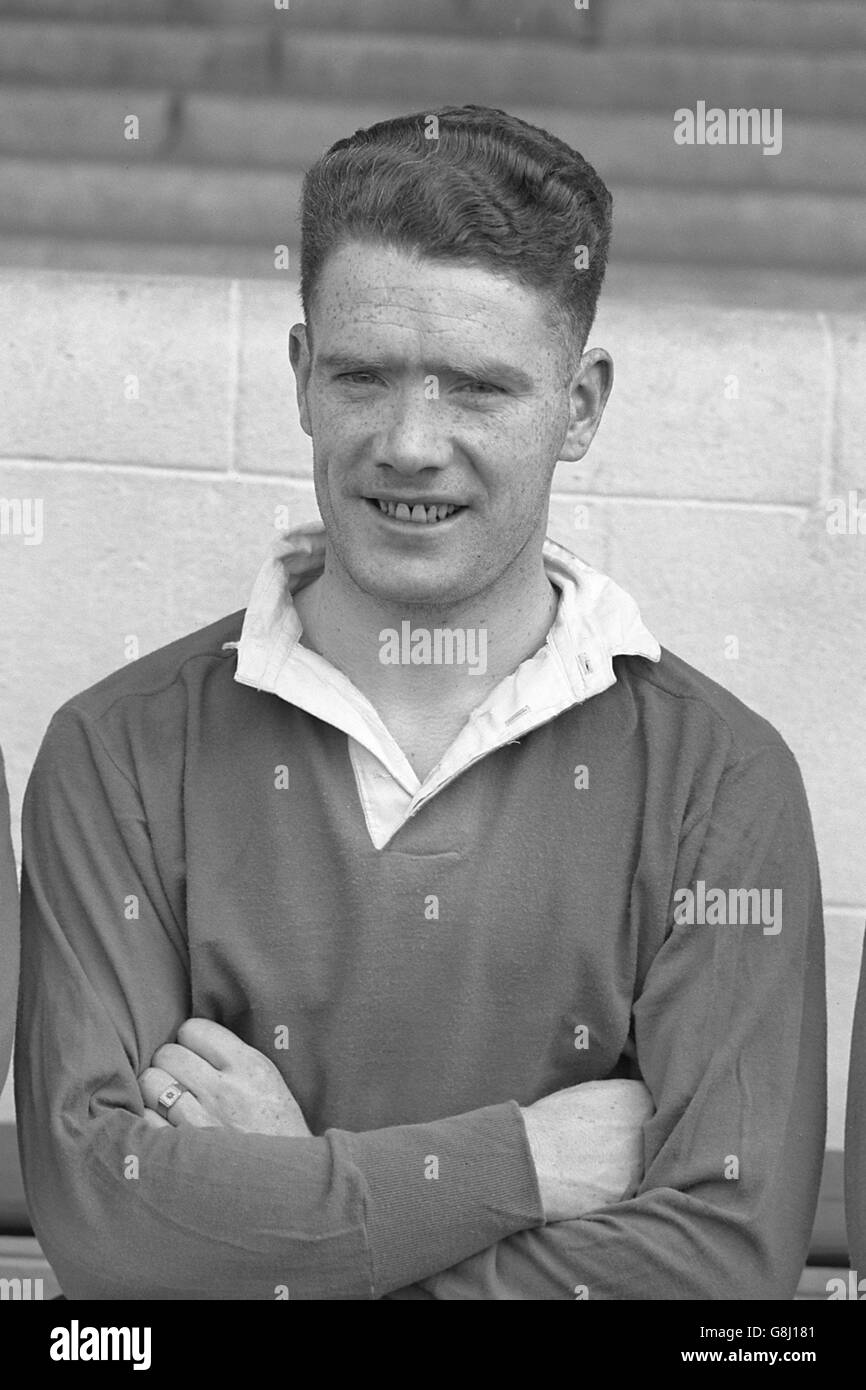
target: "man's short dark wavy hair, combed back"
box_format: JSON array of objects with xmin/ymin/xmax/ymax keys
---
[{"xmin": 300, "ymin": 106, "xmax": 613, "ymax": 357}]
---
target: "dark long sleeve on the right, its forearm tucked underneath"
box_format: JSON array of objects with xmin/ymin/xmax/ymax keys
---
[{"xmin": 396, "ymin": 741, "xmax": 826, "ymax": 1300}]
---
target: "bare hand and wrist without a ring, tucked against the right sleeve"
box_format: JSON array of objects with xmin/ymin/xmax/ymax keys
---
[{"xmin": 520, "ymin": 1080, "xmax": 653, "ymax": 1222}]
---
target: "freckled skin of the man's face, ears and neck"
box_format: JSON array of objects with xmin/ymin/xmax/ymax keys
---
[{"xmin": 289, "ymin": 242, "xmax": 613, "ymax": 777}]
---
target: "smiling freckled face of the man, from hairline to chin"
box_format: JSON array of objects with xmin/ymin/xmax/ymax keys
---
[{"xmin": 291, "ymin": 242, "xmax": 606, "ymax": 606}]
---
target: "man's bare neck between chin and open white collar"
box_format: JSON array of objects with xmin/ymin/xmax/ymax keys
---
[{"xmin": 295, "ymin": 546, "xmax": 559, "ymax": 712}]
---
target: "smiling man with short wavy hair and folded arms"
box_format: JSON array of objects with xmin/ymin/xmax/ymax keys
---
[{"xmin": 17, "ymin": 107, "xmax": 824, "ymax": 1298}]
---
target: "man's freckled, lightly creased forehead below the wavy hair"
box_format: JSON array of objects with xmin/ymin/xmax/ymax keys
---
[{"xmin": 311, "ymin": 242, "xmax": 557, "ymax": 359}]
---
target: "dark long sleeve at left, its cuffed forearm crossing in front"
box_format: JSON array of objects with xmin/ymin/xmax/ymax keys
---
[{"xmin": 15, "ymin": 706, "xmax": 542, "ymax": 1300}]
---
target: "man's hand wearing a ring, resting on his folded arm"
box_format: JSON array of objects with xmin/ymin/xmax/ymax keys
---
[{"xmin": 138, "ymin": 1019, "xmax": 313, "ymax": 1138}]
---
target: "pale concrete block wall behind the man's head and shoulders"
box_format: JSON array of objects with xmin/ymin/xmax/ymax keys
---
[{"xmin": 0, "ymin": 271, "xmax": 866, "ymax": 1148}]
